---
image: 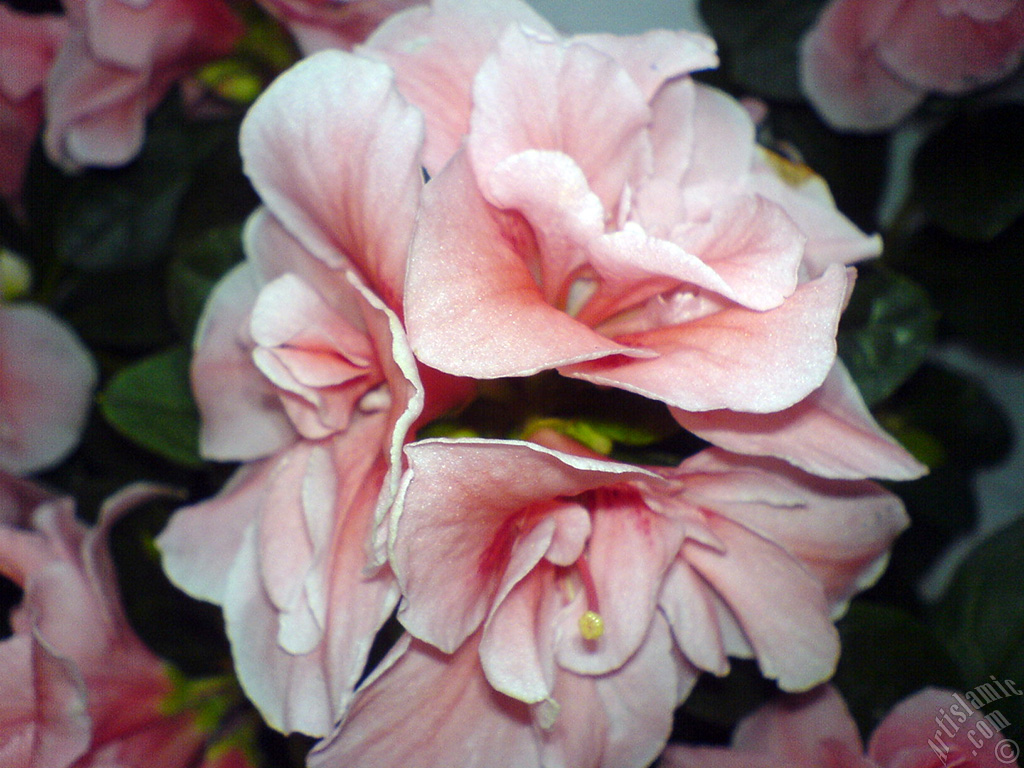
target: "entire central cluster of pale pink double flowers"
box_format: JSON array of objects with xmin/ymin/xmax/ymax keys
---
[{"xmin": 149, "ymin": 0, "xmax": 924, "ymax": 768}]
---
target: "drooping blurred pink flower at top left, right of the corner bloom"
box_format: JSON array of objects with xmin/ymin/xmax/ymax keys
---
[{"xmin": 44, "ymin": 0, "xmax": 243, "ymax": 168}]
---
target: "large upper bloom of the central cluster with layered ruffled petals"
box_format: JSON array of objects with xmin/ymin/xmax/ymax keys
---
[{"xmin": 361, "ymin": 0, "xmax": 924, "ymax": 478}]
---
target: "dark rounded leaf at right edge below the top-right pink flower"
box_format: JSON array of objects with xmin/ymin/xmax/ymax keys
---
[{"xmin": 913, "ymin": 103, "xmax": 1024, "ymax": 240}]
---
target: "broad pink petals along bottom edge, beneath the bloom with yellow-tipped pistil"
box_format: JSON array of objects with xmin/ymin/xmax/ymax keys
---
[{"xmin": 308, "ymin": 617, "xmax": 696, "ymax": 768}]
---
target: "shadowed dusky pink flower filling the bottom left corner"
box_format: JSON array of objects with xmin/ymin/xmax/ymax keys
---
[{"xmin": 0, "ymin": 475, "xmax": 249, "ymax": 768}]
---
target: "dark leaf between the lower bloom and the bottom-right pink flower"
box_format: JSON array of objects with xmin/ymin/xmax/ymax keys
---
[{"xmin": 834, "ymin": 601, "xmax": 962, "ymax": 734}]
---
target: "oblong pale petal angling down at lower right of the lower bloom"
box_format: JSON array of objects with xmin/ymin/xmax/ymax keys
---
[{"xmin": 680, "ymin": 515, "xmax": 839, "ymax": 690}]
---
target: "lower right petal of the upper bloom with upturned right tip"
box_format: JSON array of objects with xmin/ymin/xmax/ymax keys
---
[{"xmin": 559, "ymin": 266, "xmax": 849, "ymax": 413}]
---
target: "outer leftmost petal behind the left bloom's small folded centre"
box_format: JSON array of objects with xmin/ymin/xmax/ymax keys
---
[{"xmin": 191, "ymin": 264, "xmax": 297, "ymax": 461}]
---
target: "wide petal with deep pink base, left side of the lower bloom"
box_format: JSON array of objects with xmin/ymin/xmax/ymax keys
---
[{"xmin": 391, "ymin": 439, "xmax": 646, "ymax": 649}]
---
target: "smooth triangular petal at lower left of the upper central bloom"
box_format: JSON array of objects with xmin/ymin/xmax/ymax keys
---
[{"xmin": 406, "ymin": 154, "xmax": 633, "ymax": 378}]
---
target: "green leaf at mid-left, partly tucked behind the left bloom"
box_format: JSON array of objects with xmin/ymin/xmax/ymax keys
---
[{"xmin": 100, "ymin": 346, "xmax": 202, "ymax": 467}]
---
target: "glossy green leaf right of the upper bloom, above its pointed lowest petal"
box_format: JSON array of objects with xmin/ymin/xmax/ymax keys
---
[{"xmin": 838, "ymin": 265, "xmax": 937, "ymax": 406}]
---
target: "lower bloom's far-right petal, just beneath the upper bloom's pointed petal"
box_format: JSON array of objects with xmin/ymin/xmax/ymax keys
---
[{"xmin": 678, "ymin": 450, "xmax": 909, "ymax": 616}]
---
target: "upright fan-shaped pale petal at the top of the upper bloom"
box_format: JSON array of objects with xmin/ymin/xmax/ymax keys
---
[{"xmin": 468, "ymin": 28, "xmax": 650, "ymax": 212}]
